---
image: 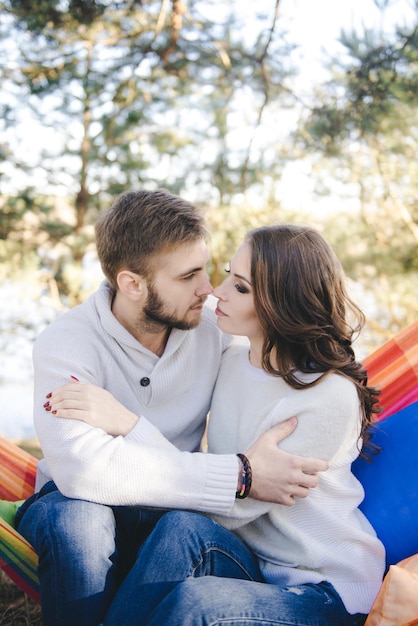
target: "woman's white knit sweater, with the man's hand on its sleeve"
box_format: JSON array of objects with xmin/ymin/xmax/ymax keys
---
[{"xmin": 208, "ymin": 346, "xmax": 384, "ymax": 613}]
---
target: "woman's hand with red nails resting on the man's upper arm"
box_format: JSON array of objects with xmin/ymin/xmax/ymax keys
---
[{"xmin": 44, "ymin": 377, "xmax": 139, "ymax": 436}]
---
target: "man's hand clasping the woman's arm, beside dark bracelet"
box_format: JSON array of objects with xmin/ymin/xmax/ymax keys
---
[{"xmin": 245, "ymin": 417, "xmax": 328, "ymax": 506}]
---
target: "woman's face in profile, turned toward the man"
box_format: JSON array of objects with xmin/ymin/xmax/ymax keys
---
[{"xmin": 213, "ymin": 242, "xmax": 263, "ymax": 341}]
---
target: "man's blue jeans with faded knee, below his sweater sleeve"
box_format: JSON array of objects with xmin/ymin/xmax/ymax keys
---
[{"xmin": 16, "ymin": 482, "xmax": 167, "ymax": 626}]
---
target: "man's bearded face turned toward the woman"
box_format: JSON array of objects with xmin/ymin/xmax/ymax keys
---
[{"xmin": 140, "ymin": 240, "xmax": 213, "ymax": 330}]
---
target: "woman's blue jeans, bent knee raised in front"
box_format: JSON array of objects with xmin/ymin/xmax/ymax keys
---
[{"xmin": 104, "ymin": 511, "xmax": 366, "ymax": 626}]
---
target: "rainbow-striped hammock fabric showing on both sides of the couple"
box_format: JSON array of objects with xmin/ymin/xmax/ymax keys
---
[{"xmin": 0, "ymin": 321, "xmax": 418, "ymax": 602}]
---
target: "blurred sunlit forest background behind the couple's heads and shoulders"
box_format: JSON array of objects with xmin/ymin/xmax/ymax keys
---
[{"xmin": 0, "ymin": 0, "xmax": 418, "ymax": 437}]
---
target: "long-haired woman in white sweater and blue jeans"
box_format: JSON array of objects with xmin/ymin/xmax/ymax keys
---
[{"xmin": 46, "ymin": 225, "xmax": 384, "ymax": 626}]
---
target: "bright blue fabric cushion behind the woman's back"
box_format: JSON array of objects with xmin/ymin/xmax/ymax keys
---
[{"xmin": 352, "ymin": 402, "xmax": 418, "ymax": 567}]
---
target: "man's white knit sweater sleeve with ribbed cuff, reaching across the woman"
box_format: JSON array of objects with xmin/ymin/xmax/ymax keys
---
[{"xmin": 33, "ymin": 322, "xmax": 238, "ymax": 514}]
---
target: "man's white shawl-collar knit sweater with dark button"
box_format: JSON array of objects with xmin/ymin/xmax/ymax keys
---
[{"xmin": 33, "ymin": 283, "xmax": 238, "ymax": 514}]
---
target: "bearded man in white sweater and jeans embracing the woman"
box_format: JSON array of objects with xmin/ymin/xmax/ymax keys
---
[{"xmin": 18, "ymin": 191, "xmax": 327, "ymax": 626}]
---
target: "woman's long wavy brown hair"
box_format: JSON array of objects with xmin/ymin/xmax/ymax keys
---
[{"xmin": 247, "ymin": 224, "xmax": 380, "ymax": 456}]
